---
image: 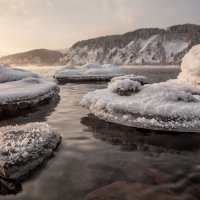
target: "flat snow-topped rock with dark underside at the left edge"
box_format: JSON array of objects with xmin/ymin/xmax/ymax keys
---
[{"xmin": 0, "ymin": 66, "xmax": 59, "ymax": 115}]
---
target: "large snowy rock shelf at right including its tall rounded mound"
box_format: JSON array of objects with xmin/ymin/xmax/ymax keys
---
[{"xmin": 81, "ymin": 45, "xmax": 200, "ymax": 129}]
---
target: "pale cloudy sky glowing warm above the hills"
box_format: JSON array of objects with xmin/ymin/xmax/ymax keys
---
[{"xmin": 0, "ymin": 0, "xmax": 200, "ymax": 56}]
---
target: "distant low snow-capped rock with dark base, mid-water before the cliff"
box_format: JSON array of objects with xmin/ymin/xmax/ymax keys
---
[{"xmin": 54, "ymin": 63, "xmax": 125, "ymax": 83}]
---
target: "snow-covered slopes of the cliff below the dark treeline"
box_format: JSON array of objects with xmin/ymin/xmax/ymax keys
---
[{"xmin": 62, "ymin": 33, "xmax": 190, "ymax": 65}]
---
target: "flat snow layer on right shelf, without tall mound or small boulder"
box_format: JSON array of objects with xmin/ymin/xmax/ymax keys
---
[{"xmin": 81, "ymin": 80, "xmax": 200, "ymax": 129}]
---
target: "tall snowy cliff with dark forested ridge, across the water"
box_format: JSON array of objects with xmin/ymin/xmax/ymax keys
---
[{"xmin": 61, "ymin": 24, "xmax": 200, "ymax": 65}]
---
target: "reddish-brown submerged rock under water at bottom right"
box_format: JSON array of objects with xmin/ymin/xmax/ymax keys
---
[{"xmin": 85, "ymin": 180, "xmax": 200, "ymax": 200}]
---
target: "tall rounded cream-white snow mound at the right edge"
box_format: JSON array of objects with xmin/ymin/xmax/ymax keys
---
[{"xmin": 178, "ymin": 44, "xmax": 200, "ymax": 84}]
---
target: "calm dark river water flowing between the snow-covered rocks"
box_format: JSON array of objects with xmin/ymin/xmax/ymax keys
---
[{"xmin": 0, "ymin": 67, "xmax": 200, "ymax": 200}]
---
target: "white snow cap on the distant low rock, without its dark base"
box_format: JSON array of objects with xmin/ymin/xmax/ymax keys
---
[{"xmin": 54, "ymin": 63, "xmax": 124, "ymax": 79}]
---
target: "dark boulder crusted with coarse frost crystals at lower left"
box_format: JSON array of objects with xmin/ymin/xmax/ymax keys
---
[{"xmin": 0, "ymin": 123, "xmax": 61, "ymax": 181}]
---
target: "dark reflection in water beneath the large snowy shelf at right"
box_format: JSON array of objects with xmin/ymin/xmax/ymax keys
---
[{"xmin": 81, "ymin": 114, "xmax": 200, "ymax": 154}]
